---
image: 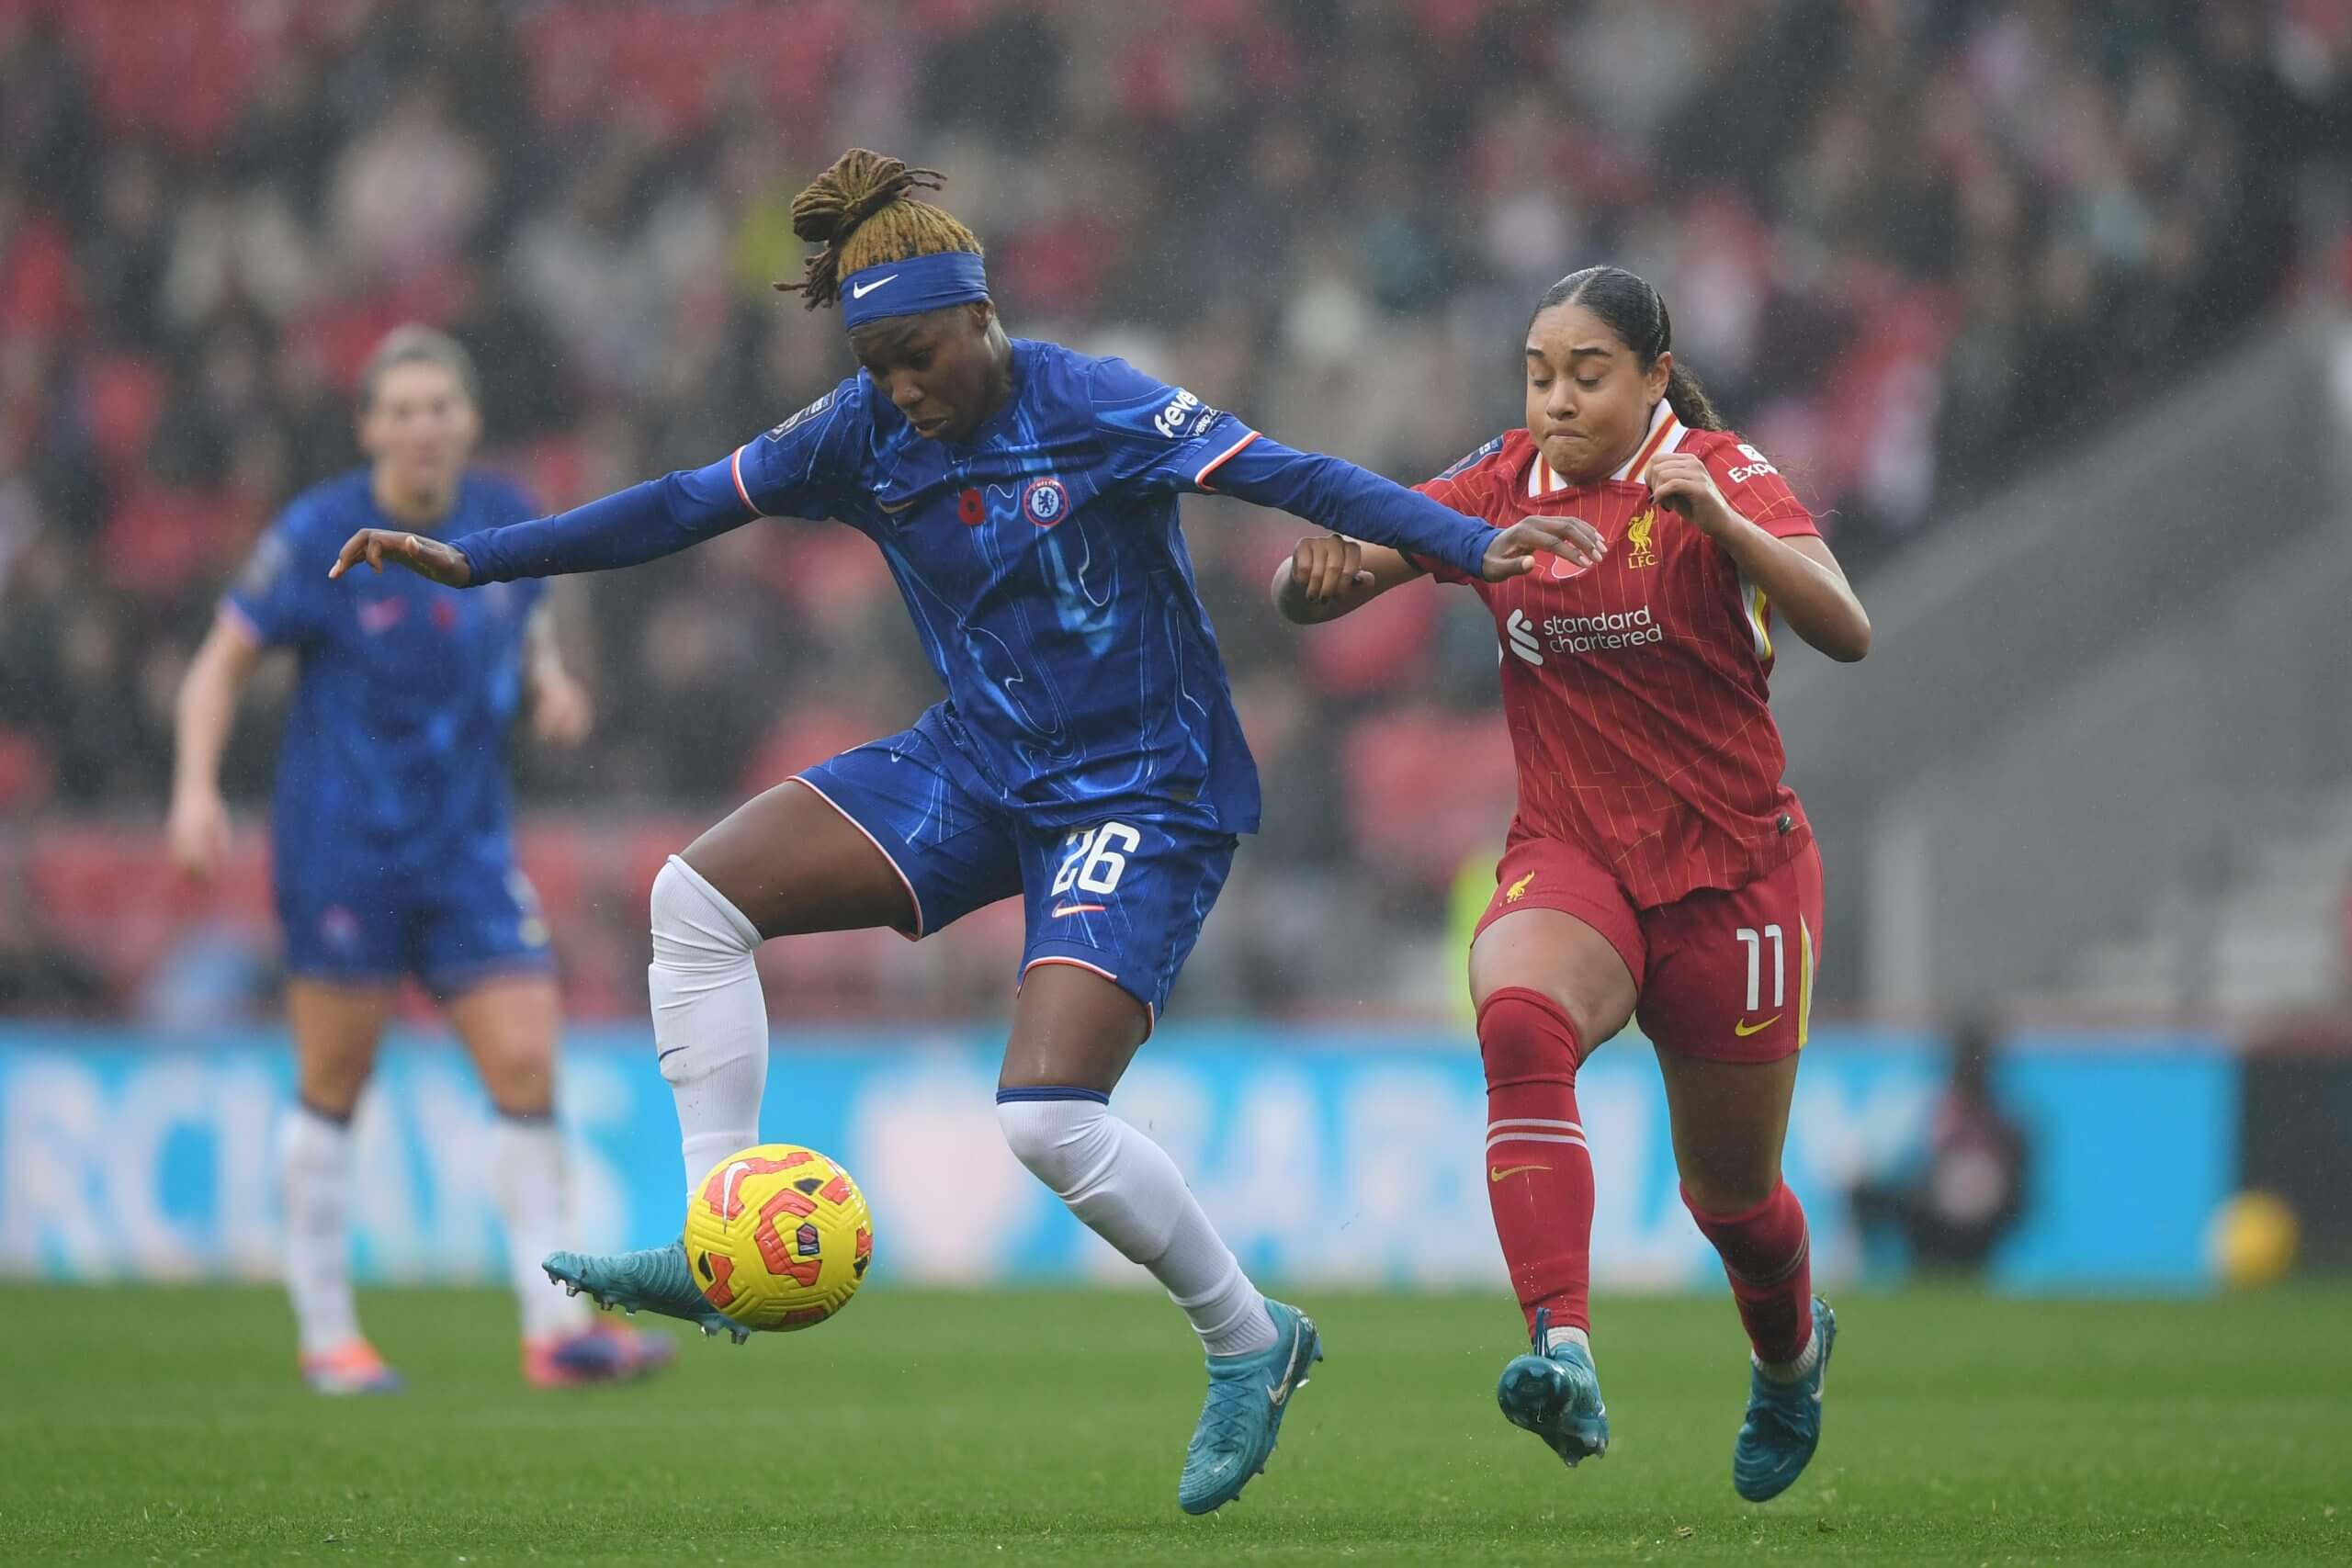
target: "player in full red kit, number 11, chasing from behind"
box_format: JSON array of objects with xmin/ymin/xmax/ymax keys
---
[{"xmin": 1275, "ymin": 268, "xmax": 1870, "ymax": 1502}]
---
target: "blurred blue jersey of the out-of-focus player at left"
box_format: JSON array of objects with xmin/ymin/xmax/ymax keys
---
[{"xmin": 223, "ymin": 470, "xmax": 543, "ymax": 884}]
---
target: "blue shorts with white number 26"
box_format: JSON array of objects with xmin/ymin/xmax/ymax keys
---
[{"xmin": 797, "ymin": 728, "xmax": 1239, "ymax": 1022}]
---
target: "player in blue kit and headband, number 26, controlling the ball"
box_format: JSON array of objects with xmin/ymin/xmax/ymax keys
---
[{"xmin": 336, "ymin": 148, "xmax": 1580, "ymax": 1514}]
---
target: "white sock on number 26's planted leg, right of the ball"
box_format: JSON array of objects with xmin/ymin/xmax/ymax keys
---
[{"xmin": 997, "ymin": 1090, "xmax": 1275, "ymax": 1357}]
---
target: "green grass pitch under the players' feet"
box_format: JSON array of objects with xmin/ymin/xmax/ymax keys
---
[{"xmin": 0, "ymin": 1286, "xmax": 2352, "ymax": 1568}]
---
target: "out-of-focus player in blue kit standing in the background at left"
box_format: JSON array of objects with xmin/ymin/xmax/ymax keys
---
[{"xmin": 169, "ymin": 327, "xmax": 671, "ymax": 1394}]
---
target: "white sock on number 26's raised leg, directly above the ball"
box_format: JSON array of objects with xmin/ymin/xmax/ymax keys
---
[{"xmin": 644, "ymin": 856, "xmax": 767, "ymax": 1194}]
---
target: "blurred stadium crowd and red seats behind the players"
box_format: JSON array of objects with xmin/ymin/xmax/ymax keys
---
[{"xmin": 0, "ymin": 0, "xmax": 2352, "ymax": 1010}]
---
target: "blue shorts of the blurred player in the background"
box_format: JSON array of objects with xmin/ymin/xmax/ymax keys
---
[{"xmin": 277, "ymin": 851, "xmax": 553, "ymax": 997}]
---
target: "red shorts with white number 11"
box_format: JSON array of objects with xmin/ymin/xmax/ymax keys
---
[{"xmin": 1477, "ymin": 837, "xmax": 1820, "ymax": 1063}]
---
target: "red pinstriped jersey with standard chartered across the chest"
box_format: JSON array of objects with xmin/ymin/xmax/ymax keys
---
[{"xmin": 1420, "ymin": 402, "xmax": 1818, "ymax": 909}]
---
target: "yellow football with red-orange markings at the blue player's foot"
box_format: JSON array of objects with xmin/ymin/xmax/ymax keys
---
[{"xmin": 687, "ymin": 1143, "xmax": 875, "ymax": 1331}]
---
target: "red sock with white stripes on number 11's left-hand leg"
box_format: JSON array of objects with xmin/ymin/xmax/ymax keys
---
[{"xmin": 1477, "ymin": 985, "xmax": 1592, "ymax": 1333}]
